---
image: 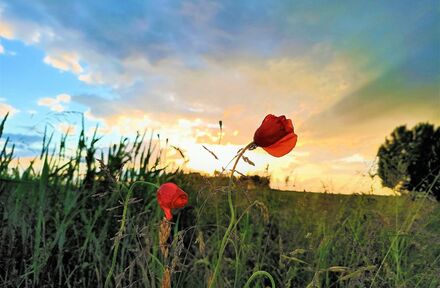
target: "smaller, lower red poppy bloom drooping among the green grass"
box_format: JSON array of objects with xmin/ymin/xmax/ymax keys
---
[{"xmin": 156, "ymin": 183, "xmax": 188, "ymax": 221}]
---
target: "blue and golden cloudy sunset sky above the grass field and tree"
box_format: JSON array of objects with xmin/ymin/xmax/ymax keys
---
[{"xmin": 0, "ymin": 0, "xmax": 440, "ymax": 194}]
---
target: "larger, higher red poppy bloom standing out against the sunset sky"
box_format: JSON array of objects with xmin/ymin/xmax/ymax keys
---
[{"xmin": 254, "ymin": 114, "xmax": 298, "ymax": 157}]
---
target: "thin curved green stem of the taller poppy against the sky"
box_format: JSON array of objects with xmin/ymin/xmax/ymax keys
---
[{"xmin": 208, "ymin": 142, "xmax": 254, "ymax": 288}]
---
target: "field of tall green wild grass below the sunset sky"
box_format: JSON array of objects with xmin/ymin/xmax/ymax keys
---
[{"xmin": 0, "ymin": 115, "xmax": 440, "ymax": 288}]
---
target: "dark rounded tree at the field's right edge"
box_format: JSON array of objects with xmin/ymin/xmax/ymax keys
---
[{"xmin": 377, "ymin": 123, "xmax": 440, "ymax": 201}]
